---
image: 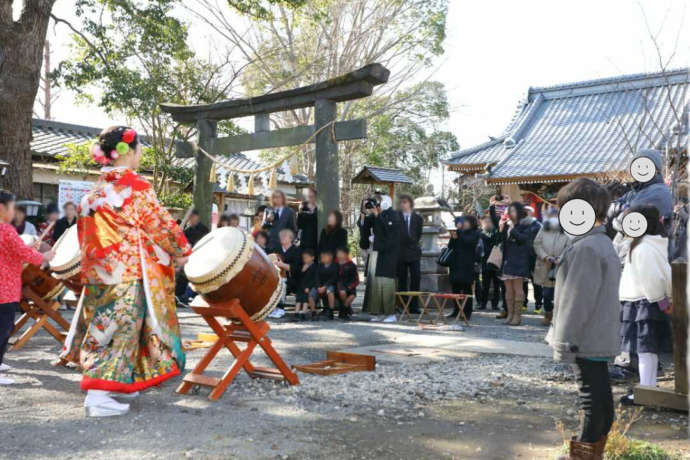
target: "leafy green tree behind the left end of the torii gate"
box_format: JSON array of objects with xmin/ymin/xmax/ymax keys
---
[{"xmin": 53, "ymin": 0, "xmax": 238, "ymax": 196}]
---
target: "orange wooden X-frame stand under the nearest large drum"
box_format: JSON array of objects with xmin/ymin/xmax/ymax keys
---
[{"xmin": 177, "ymin": 299, "xmax": 299, "ymax": 400}]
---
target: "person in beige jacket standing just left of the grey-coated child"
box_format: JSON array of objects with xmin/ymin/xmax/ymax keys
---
[{"xmin": 534, "ymin": 209, "xmax": 570, "ymax": 326}]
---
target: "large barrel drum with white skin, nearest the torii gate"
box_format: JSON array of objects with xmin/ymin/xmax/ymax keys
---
[{"xmin": 184, "ymin": 227, "xmax": 284, "ymax": 321}]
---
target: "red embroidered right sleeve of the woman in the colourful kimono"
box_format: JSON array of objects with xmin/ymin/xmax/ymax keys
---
[{"xmin": 134, "ymin": 188, "xmax": 192, "ymax": 257}]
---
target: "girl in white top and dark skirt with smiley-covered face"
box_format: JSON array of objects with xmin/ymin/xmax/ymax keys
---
[{"xmin": 620, "ymin": 205, "xmax": 672, "ymax": 404}]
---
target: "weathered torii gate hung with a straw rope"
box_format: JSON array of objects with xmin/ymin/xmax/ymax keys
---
[{"xmin": 161, "ymin": 64, "xmax": 390, "ymax": 227}]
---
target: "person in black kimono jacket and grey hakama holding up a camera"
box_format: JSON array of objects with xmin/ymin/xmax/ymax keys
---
[{"xmin": 367, "ymin": 195, "xmax": 401, "ymax": 323}]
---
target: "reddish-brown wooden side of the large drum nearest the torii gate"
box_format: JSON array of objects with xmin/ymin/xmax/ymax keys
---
[{"xmin": 196, "ymin": 248, "xmax": 280, "ymax": 319}]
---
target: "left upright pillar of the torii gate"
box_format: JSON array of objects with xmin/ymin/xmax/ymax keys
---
[{"xmin": 194, "ymin": 120, "xmax": 218, "ymax": 228}]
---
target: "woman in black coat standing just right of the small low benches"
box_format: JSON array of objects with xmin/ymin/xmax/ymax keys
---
[{"xmin": 448, "ymin": 216, "xmax": 479, "ymax": 320}]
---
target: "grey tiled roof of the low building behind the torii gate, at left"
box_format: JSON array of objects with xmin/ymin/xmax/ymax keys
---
[{"xmin": 31, "ymin": 118, "xmax": 310, "ymax": 184}]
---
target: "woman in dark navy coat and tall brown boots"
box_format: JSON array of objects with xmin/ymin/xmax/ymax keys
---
[{"xmin": 489, "ymin": 198, "xmax": 532, "ymax": 326}]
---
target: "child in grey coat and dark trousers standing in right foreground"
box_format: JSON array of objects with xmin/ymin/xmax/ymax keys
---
[{"xmin": 548, "ymin": 179, "xmax": 621, "ymax": 459}]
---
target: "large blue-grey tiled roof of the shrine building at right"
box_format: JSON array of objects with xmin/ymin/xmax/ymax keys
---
[{"xmin": 446, "ymin": 69, "xmax": 690, "ymax": 183}]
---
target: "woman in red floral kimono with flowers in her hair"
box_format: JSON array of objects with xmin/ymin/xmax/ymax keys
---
[{"xmin": 62, "ymin": 126, "xmax": 191, "ymax": 417}]
